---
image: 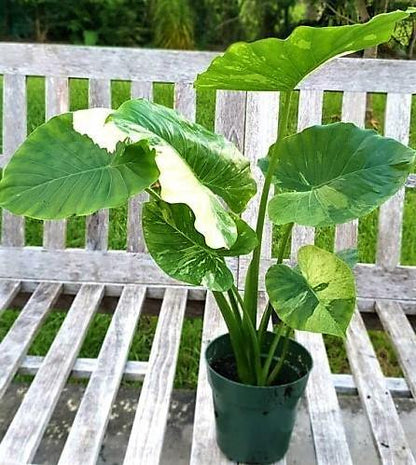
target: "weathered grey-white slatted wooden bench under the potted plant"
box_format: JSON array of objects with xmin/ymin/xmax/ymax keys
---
[{"xmin": 0, "ymin": 43, "xmax": 416, "ymax": 465}]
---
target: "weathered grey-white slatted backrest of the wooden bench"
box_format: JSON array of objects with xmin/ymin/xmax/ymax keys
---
[{"xmin": 0, "ymin": 43, "xmax": 416, "ymax": 305}]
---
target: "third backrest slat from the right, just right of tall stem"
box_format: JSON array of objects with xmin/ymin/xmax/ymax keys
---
[{"xmin": 291, "ymin": 90, "xmax": 324, "ymax": 259}]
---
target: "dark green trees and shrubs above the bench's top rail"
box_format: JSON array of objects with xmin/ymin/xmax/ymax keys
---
[{"xmin": 0, "ymin": 0, "xmax": 416, "ymax": 58}]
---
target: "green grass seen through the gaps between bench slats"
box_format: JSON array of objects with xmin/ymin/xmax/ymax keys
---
[{"xmin": 0, "ymin": 78, "xmax": 416, "ymax": 388}]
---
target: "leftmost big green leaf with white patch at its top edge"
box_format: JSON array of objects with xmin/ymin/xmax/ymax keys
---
[{"xmin": 0, "ymin": 113, "xmax": 159, "ymax": 219}]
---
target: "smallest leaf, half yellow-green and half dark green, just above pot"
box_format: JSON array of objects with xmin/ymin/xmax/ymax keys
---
[{"xmin": 266, "ymin": 245, "xmax": 355, "ymax": 337}]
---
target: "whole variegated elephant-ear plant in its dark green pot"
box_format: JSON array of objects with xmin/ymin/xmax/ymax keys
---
[{"xmin": 0, "ymin": 11, "xmax": 415, "ymax": 463}]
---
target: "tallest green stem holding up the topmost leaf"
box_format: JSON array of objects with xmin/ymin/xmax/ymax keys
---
[{"xmin": 244, "ymin": 91, "xmax": 292, "ymax": 326}]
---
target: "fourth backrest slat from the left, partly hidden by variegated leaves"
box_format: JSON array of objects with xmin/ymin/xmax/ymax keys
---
[{"xmin": 127, "ymin": 81, "xmax": 153, "ymax": 252}]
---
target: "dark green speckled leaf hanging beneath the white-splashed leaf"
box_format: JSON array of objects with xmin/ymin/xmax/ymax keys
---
[{"xmin": 143, "ymin": 201, "xmax": 257, "ymax": 291}]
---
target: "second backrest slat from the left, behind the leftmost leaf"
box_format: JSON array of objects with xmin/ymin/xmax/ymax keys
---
[{"xmin": 43, "ymin": 76, "xmax": 69, "ymax": 249}]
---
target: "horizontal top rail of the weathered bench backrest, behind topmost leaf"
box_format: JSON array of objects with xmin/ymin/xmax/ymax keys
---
[{"xmin": 0, "ymin": 42, "xmax": 416, "ymax": 93}]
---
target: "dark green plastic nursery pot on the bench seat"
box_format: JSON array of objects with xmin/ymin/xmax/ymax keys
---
[{"xmin": 205, "ymin": 333, "xmax": 312, "ymax": 464}]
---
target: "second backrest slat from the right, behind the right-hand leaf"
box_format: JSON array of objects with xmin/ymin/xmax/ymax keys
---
[{"xmin": 335, "ymin": 92, "xmax": 367, "ymax": 250}]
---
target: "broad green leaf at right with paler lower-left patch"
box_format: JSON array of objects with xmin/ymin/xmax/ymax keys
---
[{"xmin": 260, "ymin": 123, "xmax": 416, "ymax": 226}]
